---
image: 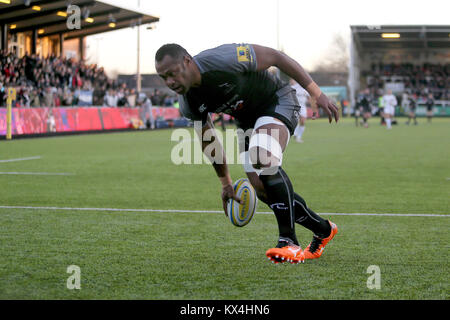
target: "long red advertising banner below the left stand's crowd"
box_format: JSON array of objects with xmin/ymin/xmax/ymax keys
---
[{"xmin": 0, "ymin": 107, "xmax": 180, "ymax": 135}]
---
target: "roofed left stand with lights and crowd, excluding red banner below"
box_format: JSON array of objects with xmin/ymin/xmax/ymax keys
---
[{"xmin": 0, "ymin": 0, "xmax": 159, "ymax": 106}]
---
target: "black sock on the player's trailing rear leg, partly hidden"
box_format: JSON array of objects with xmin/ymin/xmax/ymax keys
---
[{"xmin": 294, "ymin": 193, "xmax": 331, "ymax": 238}]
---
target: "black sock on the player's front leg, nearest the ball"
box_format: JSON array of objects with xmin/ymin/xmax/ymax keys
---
[{"xmin": 259, "ymin": 167, "xmax": 298, "ymax": 245}]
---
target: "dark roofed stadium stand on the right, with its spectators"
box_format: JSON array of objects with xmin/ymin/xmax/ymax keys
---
[{"xmin": 349, "ymin": 26, "xmax": 450, "ymax": 116}]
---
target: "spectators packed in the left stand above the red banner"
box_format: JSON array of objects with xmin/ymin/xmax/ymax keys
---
[{"xmin": 0, "ymin": 50, "xmax": 175, "ymax": 107}]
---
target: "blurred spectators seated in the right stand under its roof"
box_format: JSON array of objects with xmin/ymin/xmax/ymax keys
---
[{"xmin": 364, "ymin": 62, "xmax": 450, "ymax": 101}]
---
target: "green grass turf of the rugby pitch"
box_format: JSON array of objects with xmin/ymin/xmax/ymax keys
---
[{"xmin": 0, "ymin": 119, "xmax": 450, "ymax": 299}]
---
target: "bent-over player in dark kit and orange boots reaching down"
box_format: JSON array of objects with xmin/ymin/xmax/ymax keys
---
[{"xmin": 155, "ymin": 44, "xmax": 339, "ymax": 263}]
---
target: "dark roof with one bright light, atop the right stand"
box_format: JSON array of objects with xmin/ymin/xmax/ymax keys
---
[{"xmin": 350, "ymin": 25, "xmax": 450, "ymax": 51}]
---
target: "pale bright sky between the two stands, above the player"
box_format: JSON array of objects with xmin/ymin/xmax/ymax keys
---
[{"xmin": 86, "ymin": 0, "xmax": 450, "ymax": 75}]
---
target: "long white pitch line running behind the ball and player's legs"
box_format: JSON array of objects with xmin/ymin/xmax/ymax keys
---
[{"xmin": 0, "ymin": 206, "xmax": 444, "ymax": 218}]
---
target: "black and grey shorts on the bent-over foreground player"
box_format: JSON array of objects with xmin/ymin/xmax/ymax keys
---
[{"xmin": 236, "ymin": 85, "xmax": 301, "ymax": 135}]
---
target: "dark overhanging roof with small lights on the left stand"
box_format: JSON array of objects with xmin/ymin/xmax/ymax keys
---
[{"xmin": 0, "ymin": 0, "xmax": 159, "ymax": 39}]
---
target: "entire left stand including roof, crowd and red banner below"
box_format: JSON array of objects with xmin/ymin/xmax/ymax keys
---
[{"xmin": 0, "ymin": 0, "xmax": 187, "ymax": 138}]
